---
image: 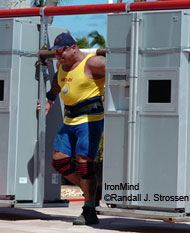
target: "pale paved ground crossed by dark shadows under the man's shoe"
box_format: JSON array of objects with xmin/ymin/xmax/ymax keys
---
[{"xmin": 0, "ymin": 202, "xmax": 190, "ymax": 233}]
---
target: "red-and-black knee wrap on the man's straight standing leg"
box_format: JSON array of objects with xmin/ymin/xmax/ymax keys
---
[{"xmin": 76, "ymin": 162, "xmax": 95, "ymax": 180}]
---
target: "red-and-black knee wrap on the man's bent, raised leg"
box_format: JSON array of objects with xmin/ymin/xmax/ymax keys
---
[{"xmin": 52, "ymin": 158, "xmax": 75, "ymax": 176}]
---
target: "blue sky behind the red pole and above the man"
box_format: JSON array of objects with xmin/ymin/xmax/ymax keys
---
[{"xmin": 53, "ymin": 0, "xmax": 133, "ymax": 43}]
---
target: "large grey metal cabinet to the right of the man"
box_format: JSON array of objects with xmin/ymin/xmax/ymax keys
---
[{"xmin": 103, "ymin": 10, "xmax": 190, "ymax": 216}]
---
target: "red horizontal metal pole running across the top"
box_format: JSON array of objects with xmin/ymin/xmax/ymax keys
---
[{"xmin": 0, "ymin": 0, "xmax": 190, "ymax": 18}]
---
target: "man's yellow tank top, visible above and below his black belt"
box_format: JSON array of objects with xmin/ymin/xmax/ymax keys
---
[{"xmin": 58, "ymin": 54, "xmax": 105, "ymax": 125}]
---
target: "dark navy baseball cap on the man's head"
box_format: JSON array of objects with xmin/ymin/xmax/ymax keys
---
[{"xmin": 50, "ymin": 32, "xmax": 77, "ymax": 50}]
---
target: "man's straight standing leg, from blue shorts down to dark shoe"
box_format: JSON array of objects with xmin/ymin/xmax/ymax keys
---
[{"xmin": 73, "ymin": 121, "xmax": 103, "ymax": 225}]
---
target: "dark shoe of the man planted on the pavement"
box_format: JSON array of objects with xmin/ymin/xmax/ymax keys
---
[{"xmin": 73, "ymin": 206, "xmax": 99, "ymax": 225}]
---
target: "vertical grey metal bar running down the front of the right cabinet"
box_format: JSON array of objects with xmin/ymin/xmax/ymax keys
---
[{"xmin": 127, "ymin": 13, "xmax": 139, "ymax": 203}]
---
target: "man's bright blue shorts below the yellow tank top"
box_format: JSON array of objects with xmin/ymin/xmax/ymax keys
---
[{"xmin": 53, "ymin": 120, "xmax": 104, "ymax": 160}]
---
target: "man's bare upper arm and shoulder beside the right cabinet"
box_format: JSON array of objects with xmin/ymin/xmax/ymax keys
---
[{"xmin": 85, "ymin": 56, "xmax": 106, "ymax": 79}]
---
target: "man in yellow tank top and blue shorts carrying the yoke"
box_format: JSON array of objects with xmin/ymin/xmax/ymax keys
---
[{"xmin": 42, "ymin": 33, "xmax": 105, "ymax": 225}]
